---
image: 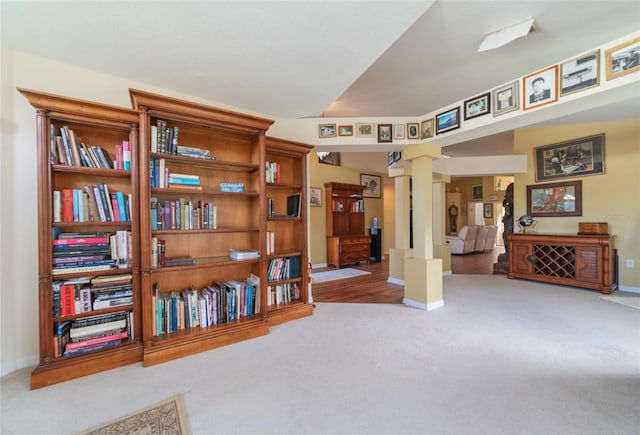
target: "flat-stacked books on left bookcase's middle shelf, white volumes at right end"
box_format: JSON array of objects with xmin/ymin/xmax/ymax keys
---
[{"xmin": 51, "ymin": 232, "xmax": 133, "ymax": 275}]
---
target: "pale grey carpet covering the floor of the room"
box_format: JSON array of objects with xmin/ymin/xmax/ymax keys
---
[{"xmin": 0, "ymin": 275, "xmax": 640, "ymax": 435}]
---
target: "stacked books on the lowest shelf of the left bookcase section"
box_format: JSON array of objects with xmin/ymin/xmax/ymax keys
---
[{"xmin": 53, "ymin": 311, "xmax": 134, "ymax": 358}]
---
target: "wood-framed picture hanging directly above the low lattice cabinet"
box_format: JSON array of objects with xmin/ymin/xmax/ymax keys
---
[{"xmin": 527, "ymin": 180, "xmax": 582, "ymax": 218}]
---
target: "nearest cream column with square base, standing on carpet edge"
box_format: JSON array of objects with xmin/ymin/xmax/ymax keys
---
[{"xmin": 402, "ymin": 143, "xmax": 444, "ymax": 310}]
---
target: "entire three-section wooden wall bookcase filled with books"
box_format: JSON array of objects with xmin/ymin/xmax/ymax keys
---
[{"xmin": 18, "ymin": 88, "xmax": 313, "ymax": 388}]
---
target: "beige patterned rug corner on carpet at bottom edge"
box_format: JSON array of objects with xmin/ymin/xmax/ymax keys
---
[{"xmin": 78, "ymin": 395, "xmax": 191, "ymax": 435}]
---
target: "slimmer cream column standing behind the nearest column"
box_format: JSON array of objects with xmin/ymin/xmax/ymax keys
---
[{"xmin": 387, "ymin": 167, "xmax": 413, "ymax": 285}]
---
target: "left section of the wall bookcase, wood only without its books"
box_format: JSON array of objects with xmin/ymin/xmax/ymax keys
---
[{"xmin": 18, "ymin": 88, "xmax": 142, "ymax": 388}]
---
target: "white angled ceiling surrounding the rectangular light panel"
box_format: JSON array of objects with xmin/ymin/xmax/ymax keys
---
[{"xmin": 0, "ymin": 0, "xmax": 640, "ymax": 160}]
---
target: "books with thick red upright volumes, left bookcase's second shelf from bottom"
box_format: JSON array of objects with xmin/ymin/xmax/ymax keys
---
[{"xmin": 51, "ymin": 274, "xmax": 133, "ymax": 317}]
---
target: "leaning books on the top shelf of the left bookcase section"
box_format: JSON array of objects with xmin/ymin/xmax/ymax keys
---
[{"xmin": 50, "ymin": 124, "xmax": 131, "ymax": 171}]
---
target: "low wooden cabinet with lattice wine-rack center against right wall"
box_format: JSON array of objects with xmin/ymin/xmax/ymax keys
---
[{"xmin": 507, "ymin": 233, "xmax": 617, "ymax": 294}]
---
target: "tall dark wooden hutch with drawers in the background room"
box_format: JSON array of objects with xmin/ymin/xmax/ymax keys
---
[{"xmin": 324, "ymin": 182, "xmax": 371, "ymax": 269}]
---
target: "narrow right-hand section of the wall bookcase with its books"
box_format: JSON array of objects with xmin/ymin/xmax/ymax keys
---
[{"xmin": 262, "ymin": 137, "xmax": 313, "ymax": 325}]
